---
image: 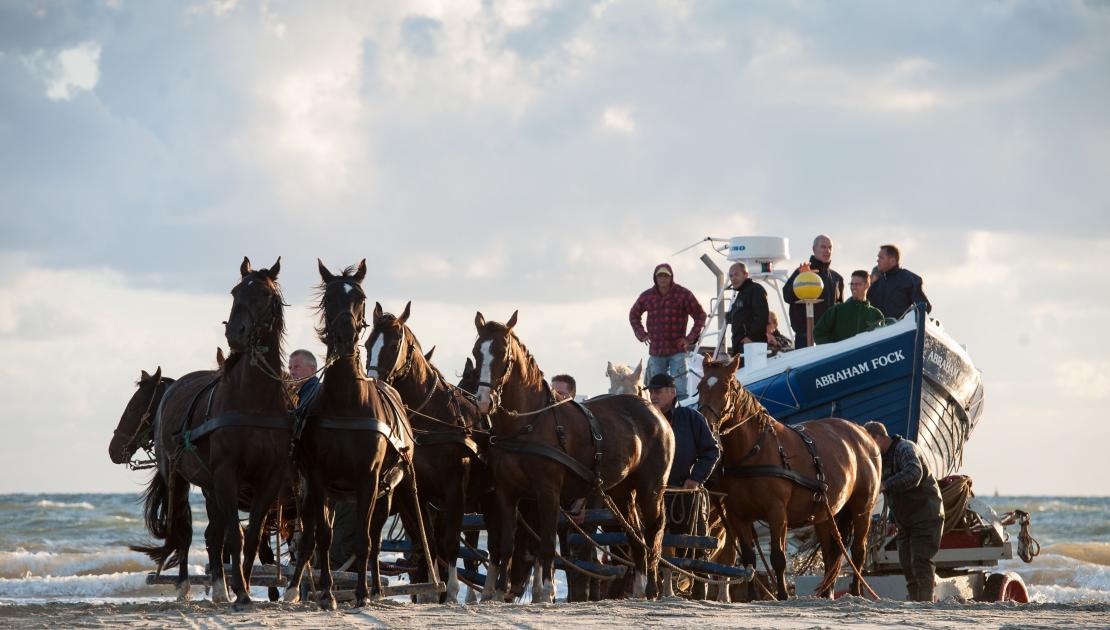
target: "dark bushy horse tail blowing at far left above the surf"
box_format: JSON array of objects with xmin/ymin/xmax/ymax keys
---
[{"xmin": 130, "ymin": 470, "xmax": 193, "ymax": 571}]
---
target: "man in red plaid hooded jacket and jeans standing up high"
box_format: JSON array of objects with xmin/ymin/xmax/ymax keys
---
[{"xmin": 628, "ymin": 263, "xmax": 705, "ymax": 399}]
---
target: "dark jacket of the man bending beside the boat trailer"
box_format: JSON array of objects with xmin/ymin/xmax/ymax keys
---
[{"xmin": 882, "ymin": 435, "xmax": 945, "ymax": 526}]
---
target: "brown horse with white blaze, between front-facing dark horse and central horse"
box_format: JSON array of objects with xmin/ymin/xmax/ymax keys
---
[{"xmin": 365, "ymin": 302, "xmax": 490, "ymax": 601}]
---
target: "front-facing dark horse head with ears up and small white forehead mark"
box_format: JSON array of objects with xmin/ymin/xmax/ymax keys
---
[{"xmin": 316, "ymin": 258, "xmax": 366, "ymax": 357}]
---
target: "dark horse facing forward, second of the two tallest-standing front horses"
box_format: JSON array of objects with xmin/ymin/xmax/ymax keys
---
[{"xmin": 285, "ymin": 260, "xmax": 427, "ymax": 610}]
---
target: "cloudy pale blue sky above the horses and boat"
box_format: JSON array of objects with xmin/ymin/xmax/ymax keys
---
[{"xmin": 0, "ymin": 0, "xmax": 1110, "ymax": 495}]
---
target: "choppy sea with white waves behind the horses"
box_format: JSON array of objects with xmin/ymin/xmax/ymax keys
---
[{"xmin": 0, "ymin": 492, "xmax": 1110, "ymax": 606}]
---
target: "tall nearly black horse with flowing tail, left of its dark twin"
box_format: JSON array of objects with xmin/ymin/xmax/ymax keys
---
[{"xmin": 131, "ymin": 256, "xmax": 292, "ymax": 608}]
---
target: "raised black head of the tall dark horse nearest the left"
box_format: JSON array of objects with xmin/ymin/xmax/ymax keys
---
[{"xmin": 224, "ymin": 256, "xmax": 285, "ymax": 353}]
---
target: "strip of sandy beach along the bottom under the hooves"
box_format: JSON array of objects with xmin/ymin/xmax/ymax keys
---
[{"xmin": 0, "ymin": 598, "xmax": 1110, "ymax": 630}]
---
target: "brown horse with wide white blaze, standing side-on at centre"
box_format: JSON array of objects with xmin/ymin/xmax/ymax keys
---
[{"xmin": 473, "ymin": 313, "xmax": 675, "ymax": 602}]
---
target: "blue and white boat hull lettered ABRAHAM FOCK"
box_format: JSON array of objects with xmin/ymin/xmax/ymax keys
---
[{"xmin": 737, "ymin": 309, "xmax": 983, "ymax": 476}]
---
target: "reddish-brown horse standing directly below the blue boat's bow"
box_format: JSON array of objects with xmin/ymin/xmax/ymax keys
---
[{"xmin": 698, "ymin": 355, "xmax": 881, "ymax": 599}]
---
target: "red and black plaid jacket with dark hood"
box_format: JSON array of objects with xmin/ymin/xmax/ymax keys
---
[{"xmin": 628, "ymin": 264, "xmax": 705, "ymax": 356}]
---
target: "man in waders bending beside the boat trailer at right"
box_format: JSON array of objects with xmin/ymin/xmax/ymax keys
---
[{"xmin": 864, "ymin": 420, "xmax": 945, "ymax": 601}]
